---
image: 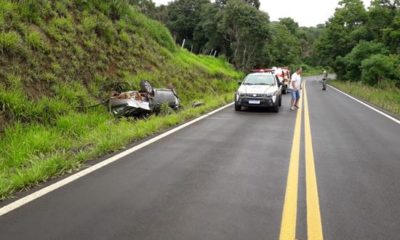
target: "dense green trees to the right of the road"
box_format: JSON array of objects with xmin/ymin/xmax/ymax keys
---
[{"xmin": 312, "ymin": 0, "xmax": 400, "ymax": 86}]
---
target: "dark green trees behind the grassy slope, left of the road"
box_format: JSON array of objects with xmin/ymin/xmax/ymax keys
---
[{"xmin": 129, "ymin": 0, "xmax": 321, "ymax": 70}]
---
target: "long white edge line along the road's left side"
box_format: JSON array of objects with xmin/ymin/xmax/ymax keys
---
[{"xmin": 0, "ymin": 103, "xmax": 233, "ymax": 216}]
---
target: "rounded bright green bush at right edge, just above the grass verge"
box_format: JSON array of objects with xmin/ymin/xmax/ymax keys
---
[{"xmin": 361, "ymin": 54, "xmax": 400, "ymax": 85}]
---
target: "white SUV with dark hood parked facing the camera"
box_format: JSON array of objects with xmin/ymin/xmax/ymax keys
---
[{"xmin": 235, "ymin": 72, "xmax": 282, "ymax": 112}]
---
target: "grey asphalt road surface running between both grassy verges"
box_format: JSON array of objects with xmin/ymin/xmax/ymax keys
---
[{"xmin": 0, "ymin": 78, "xmax": 400, "ymax": 240}]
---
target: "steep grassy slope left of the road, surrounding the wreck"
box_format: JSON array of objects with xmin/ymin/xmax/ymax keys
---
[{"xmin": 0, "ymin": 0, "xmax": 240, "ymax": 199}]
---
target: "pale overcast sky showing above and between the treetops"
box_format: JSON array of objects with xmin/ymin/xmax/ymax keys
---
[{"xmin": 153, "ymin": 0, "xmax": 370, "ymax": 27}]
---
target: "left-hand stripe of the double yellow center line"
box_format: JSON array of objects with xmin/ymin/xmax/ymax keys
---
[{"xmin": 279, "ymin": 89, "xmax": 302, "ymax": 240}]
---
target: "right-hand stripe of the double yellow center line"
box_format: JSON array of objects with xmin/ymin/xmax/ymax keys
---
[{"xmin": 303, "ymin": 83, "xmax": 323, "ymax": 240}]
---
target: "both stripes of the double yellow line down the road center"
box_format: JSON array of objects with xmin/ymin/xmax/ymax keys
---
[{"xmin": 279, "ymin": 84, "xmax": 323, "ymax": 240}]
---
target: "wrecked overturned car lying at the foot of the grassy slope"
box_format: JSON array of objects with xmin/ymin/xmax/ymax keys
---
[{"xmin": 109, "ymin": 81, "xmax": 180, "ymax": 117}]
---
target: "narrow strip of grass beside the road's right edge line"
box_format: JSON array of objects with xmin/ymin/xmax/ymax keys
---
[{"xmin": 329, "ymin": 80, "xmax": 400, "ymax": 117}]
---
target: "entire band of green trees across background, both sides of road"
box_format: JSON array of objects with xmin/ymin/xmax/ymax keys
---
[{"xmin": 130, "ymin": 0, "xmax": 400, "ymax": 86}]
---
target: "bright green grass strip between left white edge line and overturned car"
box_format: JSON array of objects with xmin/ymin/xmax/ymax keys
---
[{"xmin": 0, "ymin": 93, "xmax": 232, "ymax": 199}]
